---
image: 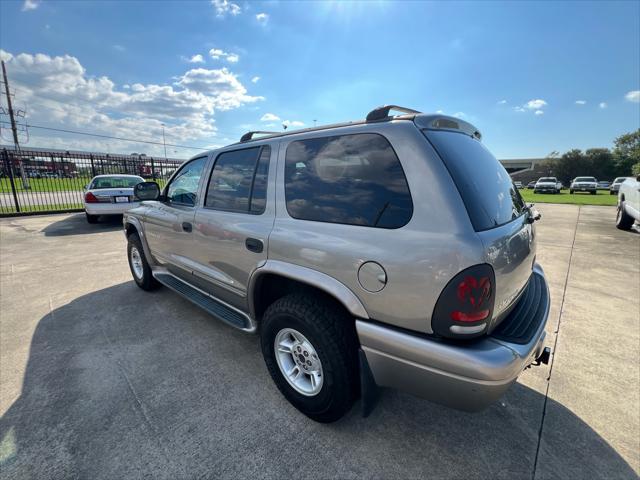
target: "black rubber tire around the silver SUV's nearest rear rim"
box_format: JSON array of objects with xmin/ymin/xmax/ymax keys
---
[{"xmin": 260, "ymin": 294, "xmax": 359, "ymax": 423}]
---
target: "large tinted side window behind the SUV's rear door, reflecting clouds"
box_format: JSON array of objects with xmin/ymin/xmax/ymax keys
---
[{"xmin": 285, "ymin": 133, "xmax": 413, "ymax": 228}]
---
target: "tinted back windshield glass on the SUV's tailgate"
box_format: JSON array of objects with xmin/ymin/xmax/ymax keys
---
[{"xmin": 424, "ymin": 130, "xmax": 525, "ymax": 231}]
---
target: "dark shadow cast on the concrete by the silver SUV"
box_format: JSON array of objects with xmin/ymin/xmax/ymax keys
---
[{"xmin": 0, "ymin": 282, "xmax": 636, "ymax": 479}]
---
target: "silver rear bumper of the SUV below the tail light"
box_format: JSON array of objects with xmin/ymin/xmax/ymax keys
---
[{"xmin": 356, "ymin": 265, "xmax": 550, "ymax": 411}]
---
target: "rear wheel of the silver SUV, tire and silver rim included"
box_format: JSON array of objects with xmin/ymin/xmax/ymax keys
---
[{"xmin": 260, "ymin": 294, "xmax": 358, "ymax": 423}]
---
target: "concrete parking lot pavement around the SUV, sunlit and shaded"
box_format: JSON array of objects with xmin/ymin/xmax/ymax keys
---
[{"xmin": 0, "ymin": 204, "xmax": 640, "ymax": 479}]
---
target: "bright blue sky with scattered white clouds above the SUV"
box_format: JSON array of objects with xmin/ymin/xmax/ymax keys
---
[{"xmin": 0, "ymin": 0, "xmax": 640, "ymax": 158}]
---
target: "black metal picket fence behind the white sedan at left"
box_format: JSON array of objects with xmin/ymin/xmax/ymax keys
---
[{"xmin": 0, "ymin": 148, "xmax": 183, "ymax": 216}]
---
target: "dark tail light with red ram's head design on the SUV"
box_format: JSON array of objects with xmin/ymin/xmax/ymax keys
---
[{"xmin": 431, "ymin": 264, "xmax": 495, "ymax": 338}]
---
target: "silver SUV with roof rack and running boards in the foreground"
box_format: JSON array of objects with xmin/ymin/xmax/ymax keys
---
[{"xmin": 124, "ymin": 106, "xmax": 550, "ymax": 422}]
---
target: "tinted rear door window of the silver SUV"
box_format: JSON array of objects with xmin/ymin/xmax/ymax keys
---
[{"xmin": 205, "ymin": 145, "xmax": 271, "ymax": 213}]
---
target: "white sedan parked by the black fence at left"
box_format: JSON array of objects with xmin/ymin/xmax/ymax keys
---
[{"xmin": 84, "ymin": 175, "xmax": 144, "ymax": 223}]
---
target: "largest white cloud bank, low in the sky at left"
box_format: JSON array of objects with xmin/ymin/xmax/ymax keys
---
[{"xmin": 0, "ymin": 49, "xmax": 263, "ymax": 156}]
